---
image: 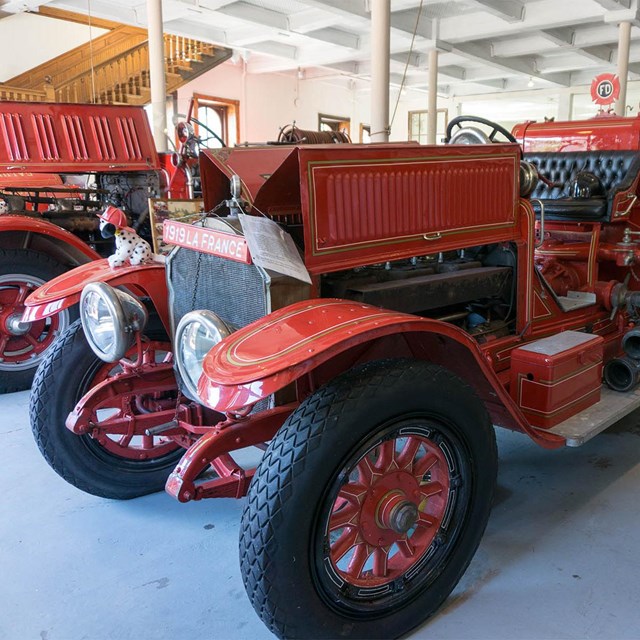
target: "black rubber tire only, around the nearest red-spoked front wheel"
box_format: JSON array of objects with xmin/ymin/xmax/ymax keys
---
[{"xmin": 240, "ymin": 360, "xmax": 497, "ymax": 639}]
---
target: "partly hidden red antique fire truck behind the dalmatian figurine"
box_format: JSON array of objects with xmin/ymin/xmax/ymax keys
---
[{"xmin": 0, "ymin": 102, "xmax": 210, "ymax": 393}]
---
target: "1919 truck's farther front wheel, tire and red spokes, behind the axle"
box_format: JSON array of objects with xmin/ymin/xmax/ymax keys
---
[{"xmin": 29, "ymin": 320, "xmax": 183, "ymax": 499}]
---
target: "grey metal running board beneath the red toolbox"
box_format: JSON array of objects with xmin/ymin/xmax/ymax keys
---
[{"xmin": 537, "ymin": 385, "xmax": 640, "ymax": 447}]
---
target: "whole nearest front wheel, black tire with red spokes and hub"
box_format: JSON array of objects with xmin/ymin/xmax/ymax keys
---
[{"xmin": 240, "ymin": 360, "xmax": 497, "ymax": 638}]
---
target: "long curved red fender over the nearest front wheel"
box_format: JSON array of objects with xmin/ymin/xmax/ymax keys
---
[{"xmin": 198, "ymin": 299, "xmax": 563, "ymax": 447}]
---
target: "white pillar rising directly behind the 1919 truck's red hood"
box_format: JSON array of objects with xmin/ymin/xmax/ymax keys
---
[{"xmin": 371, "ymin": 0, "xmax": 391, "ymax": 142}]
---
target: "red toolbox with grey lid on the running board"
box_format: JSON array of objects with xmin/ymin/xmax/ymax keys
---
[{"xmin": 510, "ymin": 331, "xmax": 603, "ymax": 429}]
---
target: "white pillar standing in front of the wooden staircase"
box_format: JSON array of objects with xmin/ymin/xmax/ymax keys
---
[{"xmin": 147, "ymin": 0, "xmax": 168, "ymax": 151}]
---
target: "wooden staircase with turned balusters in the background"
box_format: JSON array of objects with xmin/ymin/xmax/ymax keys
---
[{"xmin": 0, "ymin": 25, "xmax": 231, "ymax": 105}]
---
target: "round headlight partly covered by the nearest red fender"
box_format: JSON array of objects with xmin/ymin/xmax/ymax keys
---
[{"xmin": 175, "ymin": 311, "xmax": 233, "ymax": 401}]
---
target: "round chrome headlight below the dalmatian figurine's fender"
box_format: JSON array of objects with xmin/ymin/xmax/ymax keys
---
[{"xmin": 80, "ymin": 282, "xmax": 149, "ymax": 362}]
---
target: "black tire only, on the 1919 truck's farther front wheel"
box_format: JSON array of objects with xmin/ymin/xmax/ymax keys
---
[{"xmin": 29, "ymin": 320, "xmax": 184, "ymax": 500}]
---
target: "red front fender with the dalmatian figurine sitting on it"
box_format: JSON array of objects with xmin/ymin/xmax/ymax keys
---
[{"xmin": 23, "ymin": 259, "xmax": 170, "ymax": 330}]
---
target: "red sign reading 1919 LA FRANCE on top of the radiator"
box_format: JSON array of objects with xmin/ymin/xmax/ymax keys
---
[{"xmin": 162, "ymin": 219, "xmax": 251, "ymax": 264}]
